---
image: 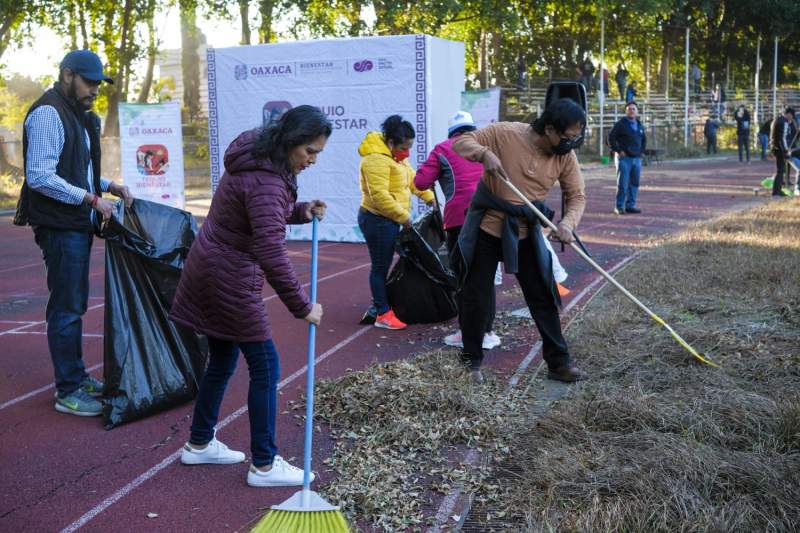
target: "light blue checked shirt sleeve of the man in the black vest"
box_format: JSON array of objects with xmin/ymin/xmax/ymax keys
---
[{"xmin": 25, "ymin": 106, "xmax": 86, "ymax": 205}]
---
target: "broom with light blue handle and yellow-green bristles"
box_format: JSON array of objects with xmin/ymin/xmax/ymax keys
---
[{"xmin": 252, "ymin": 217, "xmax": 350, "ymax": 533}]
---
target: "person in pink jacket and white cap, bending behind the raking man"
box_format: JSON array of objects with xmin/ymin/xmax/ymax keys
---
[{"xmin": 414, "ymin": 111, "xmax": 500, "ymax": 350}]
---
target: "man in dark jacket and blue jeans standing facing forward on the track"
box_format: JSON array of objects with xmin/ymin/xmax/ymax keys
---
[{"xmin": 608, "ymin": 102, "xmax": 647, "ymax": 215}]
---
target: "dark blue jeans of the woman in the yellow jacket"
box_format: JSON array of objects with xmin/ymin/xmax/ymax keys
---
[{"xmin": 358, "ymin": 208, "xmax": 400, "ymax": 315}]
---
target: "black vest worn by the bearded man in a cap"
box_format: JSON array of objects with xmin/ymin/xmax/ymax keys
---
[{"xmin": 14, "ymin": 84, "xmax": 100, "ymax": 232}]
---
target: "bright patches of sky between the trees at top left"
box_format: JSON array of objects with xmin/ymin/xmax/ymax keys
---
[{"xmin": 2, "ymin": 7, "xmax": 247, "ymax": 79}]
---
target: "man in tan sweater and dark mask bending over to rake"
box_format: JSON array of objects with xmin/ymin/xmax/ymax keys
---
[{"xmin": 453, "ymin": 99, "xmax": 586, "ymax": 382}]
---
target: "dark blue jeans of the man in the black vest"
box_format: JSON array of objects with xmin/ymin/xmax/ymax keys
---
[{"xmin": 34, "ymin": 227, "xmax": 92, "ymax": 398}]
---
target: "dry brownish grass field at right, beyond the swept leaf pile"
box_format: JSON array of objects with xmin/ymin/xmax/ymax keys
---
[{"xmin": 504, "ymin": 202, "xmax": 800, "ymax": 532}]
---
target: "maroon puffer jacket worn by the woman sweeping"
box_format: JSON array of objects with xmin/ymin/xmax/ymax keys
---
[{"xmin": 169, "ymin": 130, "xmax": 311, "ymax": 342}]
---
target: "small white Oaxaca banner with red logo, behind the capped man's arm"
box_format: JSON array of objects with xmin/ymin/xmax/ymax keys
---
[{"xmin": 119, "ymin": 102, "xmax": 184, "ymax": 209}]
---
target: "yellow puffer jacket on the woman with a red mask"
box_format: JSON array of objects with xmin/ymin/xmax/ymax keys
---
[{"xmin": 358, "ymin": 131, "xmax": 433, "ymax": 224}]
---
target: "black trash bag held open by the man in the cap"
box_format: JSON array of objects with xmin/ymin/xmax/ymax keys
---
[{"xmin": 101, "ymin": 200, "xmax": 208, "ymax": 429}]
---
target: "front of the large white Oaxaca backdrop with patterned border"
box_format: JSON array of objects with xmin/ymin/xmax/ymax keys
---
[{"xmin": 208, "ymin": 35, "xmax": 464, "ymax": 242}]
